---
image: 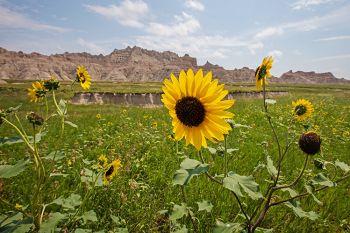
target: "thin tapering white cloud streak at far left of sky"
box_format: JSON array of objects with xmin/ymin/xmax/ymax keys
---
[{"xmin": 0, "ymin": 6, "xmax": 68, "ymax": 32}]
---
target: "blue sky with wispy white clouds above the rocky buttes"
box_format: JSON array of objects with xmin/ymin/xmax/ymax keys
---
[{"xmin": 0, "ymin": 0, "xmax": 350, "ymax": 79}]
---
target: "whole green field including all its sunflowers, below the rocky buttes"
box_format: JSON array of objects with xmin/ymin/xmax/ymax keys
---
[{"xmin": 0, "ymin": 57, "xmax": 350, "ymax": 232}]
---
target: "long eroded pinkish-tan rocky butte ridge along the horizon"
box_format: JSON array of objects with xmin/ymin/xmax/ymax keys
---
[{"xmin": 0, "ymin": 46, "xmax": 350, "ymax": 84}]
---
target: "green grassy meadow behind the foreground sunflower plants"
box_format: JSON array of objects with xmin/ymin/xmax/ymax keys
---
[{"xmin": 0, "ymin": 81, "xmax": 350, "ymax": 233}]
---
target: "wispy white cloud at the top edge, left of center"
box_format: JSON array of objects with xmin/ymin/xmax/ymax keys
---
[{"xmin": 85, "ymin": 0, "xmax": 149, "ymax": 28}]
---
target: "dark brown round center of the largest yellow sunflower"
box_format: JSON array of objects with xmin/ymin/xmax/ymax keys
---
[{"xmin": 175, "ymin": 96, "xmax": 205, "ymax": 127}]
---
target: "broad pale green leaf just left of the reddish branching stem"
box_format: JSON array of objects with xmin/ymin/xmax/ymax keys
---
[{"xmin": 223, "ymin": 172, "xmax": 263, "ymax": 200}]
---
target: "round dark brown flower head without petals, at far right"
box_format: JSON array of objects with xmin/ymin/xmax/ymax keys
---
[{"xmin": 299, "ymin": 131, "xmax": 321, "ymax": 155}]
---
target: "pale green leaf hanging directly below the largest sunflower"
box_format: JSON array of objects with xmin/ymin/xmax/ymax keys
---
[{"xmin": 173, "ymin": 158, "xmax": 208, "ymax": 185}]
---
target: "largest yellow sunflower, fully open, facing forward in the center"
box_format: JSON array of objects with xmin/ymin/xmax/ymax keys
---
[{"xmin": 162, "ymin": 69, "xmax": 234, "ymax": 150}]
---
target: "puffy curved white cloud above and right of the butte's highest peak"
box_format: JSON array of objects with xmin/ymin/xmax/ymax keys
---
[{"xmin": 146, "ymin": 12, "xmax": 200, "ymax": 37}]
